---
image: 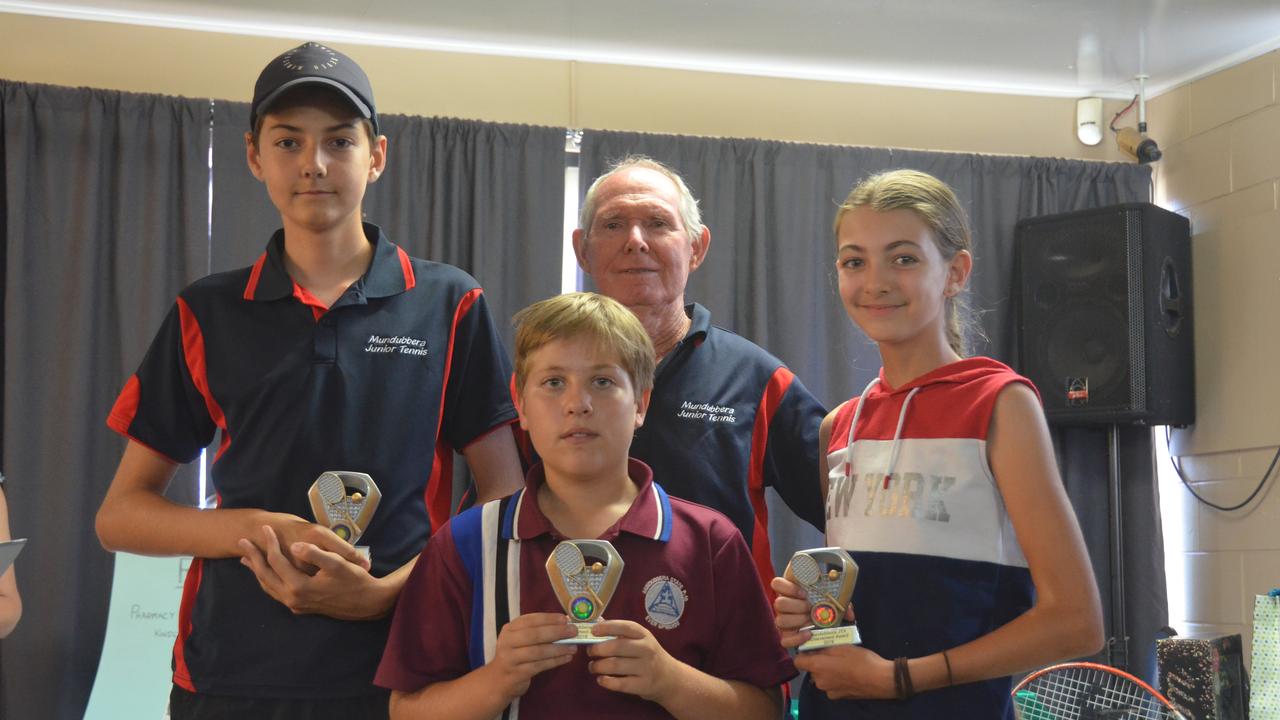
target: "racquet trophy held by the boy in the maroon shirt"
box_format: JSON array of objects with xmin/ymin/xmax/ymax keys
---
[{"xmin": 547, "ymin": 541, "xmax": 622, "ymax": 644}]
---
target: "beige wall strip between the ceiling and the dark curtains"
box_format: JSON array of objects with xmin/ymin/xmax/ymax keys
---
[{"xmin": 0, "ymin": 13, "xmax": 1123, "ymax": 160}]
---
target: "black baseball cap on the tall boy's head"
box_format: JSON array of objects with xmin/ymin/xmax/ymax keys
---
[{"xmin": 248, "ymin": 42, "xmax": 378, "ymax": 135}]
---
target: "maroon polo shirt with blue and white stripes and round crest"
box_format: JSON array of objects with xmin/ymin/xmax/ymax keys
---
[{"xmin": 376, "ymin": 460, "xmax": 795, "ymax": 720}]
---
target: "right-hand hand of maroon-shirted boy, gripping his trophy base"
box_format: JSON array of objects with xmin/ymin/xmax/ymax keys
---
[{"xmin": 588, "ymin": 620, "xmax": 682, "ymax": 705}]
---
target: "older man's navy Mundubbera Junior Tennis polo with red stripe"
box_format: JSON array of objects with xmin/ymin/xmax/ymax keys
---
[{"xmin": 631, "ymin": 302, "xmax": 827, "ymax": 587}]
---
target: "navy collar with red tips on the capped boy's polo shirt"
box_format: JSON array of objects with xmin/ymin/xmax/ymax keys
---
[{"xmin": 244, "ymin": 223, "xmax": 416, "ymax": 301}]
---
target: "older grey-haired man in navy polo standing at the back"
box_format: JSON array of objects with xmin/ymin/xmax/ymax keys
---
[{"xmin": 573, "ymin": 156, "xmax": 826, "ymax": 587}]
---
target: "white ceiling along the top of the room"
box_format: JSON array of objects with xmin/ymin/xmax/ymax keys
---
[{"xmin": 0, "ymin": 0, "xmax": 1280, "ymax": 97}]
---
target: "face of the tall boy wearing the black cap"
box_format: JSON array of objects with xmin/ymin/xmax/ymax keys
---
[{"xmin": 246, "ymin": 105, "xmax": 387, "ymax": 232}]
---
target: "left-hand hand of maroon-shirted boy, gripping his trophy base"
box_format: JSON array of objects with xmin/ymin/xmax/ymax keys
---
[{"xmin": 483, "ymin": 612, "xmax": 577, "ymax": 700}]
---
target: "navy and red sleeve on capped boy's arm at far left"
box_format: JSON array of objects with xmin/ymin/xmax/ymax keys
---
[{"xmin": 106, "ymin": 297, "xmax": 216, "ymax": 462}]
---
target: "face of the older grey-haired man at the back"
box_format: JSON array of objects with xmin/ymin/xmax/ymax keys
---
[{"xmin": 573, "ymin": 168, "xmax": 710, "ymax": 310}]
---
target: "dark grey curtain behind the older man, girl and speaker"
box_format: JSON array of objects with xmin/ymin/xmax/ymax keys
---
[{"xmin": 580, "ymin": 131, "xmax": 1167, "ymax": 676}]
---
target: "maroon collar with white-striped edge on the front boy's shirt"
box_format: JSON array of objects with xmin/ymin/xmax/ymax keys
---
[{"xmin": 502, "ymin": 457, "xmax": 671, "ymax": 542}]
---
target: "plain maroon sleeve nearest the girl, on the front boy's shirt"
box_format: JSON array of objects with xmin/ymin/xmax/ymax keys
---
[{"xmin": 703, "ymin": 521, "xmax": 796, "ymax": 688}]
